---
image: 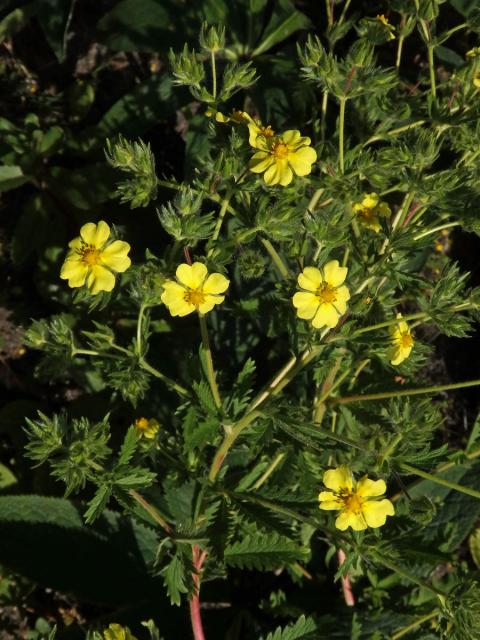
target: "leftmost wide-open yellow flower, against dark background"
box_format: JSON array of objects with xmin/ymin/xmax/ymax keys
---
[{"xmin": 60, "ymin": 220, "xmax": 131, "ymax": 295}]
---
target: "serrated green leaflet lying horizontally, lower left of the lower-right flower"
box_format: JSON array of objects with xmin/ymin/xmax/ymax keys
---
[{"xmin": 224, "ymin": 533, "xmax": 305, "ymax": 570}]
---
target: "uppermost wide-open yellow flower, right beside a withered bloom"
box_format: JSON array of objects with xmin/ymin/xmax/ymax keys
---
[{"xmin": 250, "ymin": 129, "xmax": 317, "ymax": 187}]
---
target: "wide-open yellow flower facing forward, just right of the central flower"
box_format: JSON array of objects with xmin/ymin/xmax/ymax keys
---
[{"xmin": 292, "ymin": 260, "xmax": 350, "ymax": 329}]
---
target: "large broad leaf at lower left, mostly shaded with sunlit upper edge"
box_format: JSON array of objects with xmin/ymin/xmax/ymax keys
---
[{"xmin": 0, "ymin": 495, "xmax": 159, "ymax": 606}]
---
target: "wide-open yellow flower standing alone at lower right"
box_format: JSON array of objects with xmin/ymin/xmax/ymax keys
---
[{"xmin": 318, "ymin": 466, "xmax": 395, "ymax": 531}]
